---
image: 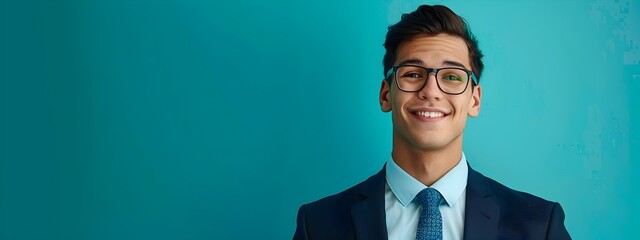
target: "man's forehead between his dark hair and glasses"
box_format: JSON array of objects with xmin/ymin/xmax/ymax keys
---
[{"xmin": 395, "ymin": 33, "xmax": 471, "ymax": 69}]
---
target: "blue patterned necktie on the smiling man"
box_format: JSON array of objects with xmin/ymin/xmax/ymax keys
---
[{"xmin": 416, "ymin": 188, "xmax": 442, "ymax": 240}]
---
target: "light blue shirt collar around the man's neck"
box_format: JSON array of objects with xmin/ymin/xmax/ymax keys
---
[{"xmin": 386, "ymin": 152, "xmax": 469, "ymax": 207}]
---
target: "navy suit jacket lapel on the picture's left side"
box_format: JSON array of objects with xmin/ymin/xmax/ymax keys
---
[{"xmin": 351, "ymin": 167, "xmax": 387, "ymax": 240}]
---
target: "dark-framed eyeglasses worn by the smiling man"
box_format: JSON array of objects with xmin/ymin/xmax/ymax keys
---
[{"xmin": 386, "ymin": 65, "xmax": 478, "ymax": 95}]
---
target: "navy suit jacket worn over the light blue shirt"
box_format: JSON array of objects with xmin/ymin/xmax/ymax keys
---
[{"xmin": 293, "ymin": 167, "xmax": 571, "ymax": 240}]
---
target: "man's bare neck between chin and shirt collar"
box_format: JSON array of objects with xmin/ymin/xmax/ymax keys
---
[{"xmin": 391, "ymin": 135, "xmax": 462, "ymax": 186}]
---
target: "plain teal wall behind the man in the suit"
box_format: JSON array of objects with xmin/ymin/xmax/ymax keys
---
[{"xmin": 0, "ymin": 0, "xmax": 640, "ymax": 239}]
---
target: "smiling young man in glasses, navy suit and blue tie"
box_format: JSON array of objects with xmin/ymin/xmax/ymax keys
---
[{"xmin": 293, "ymin": 5, "xmax": 571, "ymax": 239}]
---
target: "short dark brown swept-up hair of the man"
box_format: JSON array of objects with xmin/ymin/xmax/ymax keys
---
[{"xmin": 382, "ymin": 5, "xmax": 484, "ymax": 83}]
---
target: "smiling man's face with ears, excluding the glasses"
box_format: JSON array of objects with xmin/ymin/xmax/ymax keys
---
[{"xmin": 380, "ymin": 34, "xmax": 482, "ymax": 151}]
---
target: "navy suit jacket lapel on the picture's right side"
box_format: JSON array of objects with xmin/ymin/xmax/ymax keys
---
[{"xmin": 464, "ymin": 167, "xmax": 500, "ymax": 240}]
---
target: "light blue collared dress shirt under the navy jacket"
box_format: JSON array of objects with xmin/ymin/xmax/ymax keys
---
[{"xmin": 384, "ymin": 153, "xmax": 469, "ymax": 240}]
